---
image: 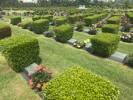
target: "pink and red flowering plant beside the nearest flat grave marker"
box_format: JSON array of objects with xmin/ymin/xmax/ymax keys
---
[{"xmin": 28, "ymin": 65, "xmax": 52, "ymax": 91}]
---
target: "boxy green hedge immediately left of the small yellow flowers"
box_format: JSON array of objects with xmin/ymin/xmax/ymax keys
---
[{"xmin": 54, "ymin": 24, "xmax": 73, "ymax": 42}]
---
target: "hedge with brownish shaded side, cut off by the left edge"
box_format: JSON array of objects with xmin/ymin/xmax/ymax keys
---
[{"xmin": 0, "ymin": 23, "xmax": 11, "ymax": 39}]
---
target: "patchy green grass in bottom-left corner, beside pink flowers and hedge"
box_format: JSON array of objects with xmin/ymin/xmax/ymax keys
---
[{"xmin": 0, "ymin": 55, "xmax": 40, "ymax": 100}]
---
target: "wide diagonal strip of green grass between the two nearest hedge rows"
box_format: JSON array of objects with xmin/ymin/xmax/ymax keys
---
[{"xmin": 12, "ymin": 27, "xmax": 133, "ymax": 100}]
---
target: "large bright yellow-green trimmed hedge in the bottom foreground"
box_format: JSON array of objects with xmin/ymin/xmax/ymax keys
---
[{"xmin": 44, "ymin": 67, "xmax": 119, "ymax": 100}]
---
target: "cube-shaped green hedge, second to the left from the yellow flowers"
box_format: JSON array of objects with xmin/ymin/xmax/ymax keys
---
[{"xmin": 32, "ymin": 19, "xmax": 49, "ymax": 34}]
